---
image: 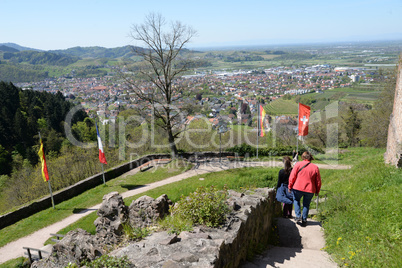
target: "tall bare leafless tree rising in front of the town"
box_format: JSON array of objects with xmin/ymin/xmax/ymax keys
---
[{"xmin": 126, "ymin": 13, "xmax": 196, "ymax": 157}]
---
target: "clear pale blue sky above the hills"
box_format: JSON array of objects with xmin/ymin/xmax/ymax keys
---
[{"xmin": 0, "ymin": 0, "xmax": 402, "ymax": 50}]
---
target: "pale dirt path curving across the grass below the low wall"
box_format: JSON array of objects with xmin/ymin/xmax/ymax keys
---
[{"xmin": 0, "ymin": 159, "xmax": 350, "ymax": 263}]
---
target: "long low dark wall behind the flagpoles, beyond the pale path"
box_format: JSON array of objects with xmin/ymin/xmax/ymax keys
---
[{"xmin": 0, "ymin": 152, "xmax": 234, "ymax": 229}]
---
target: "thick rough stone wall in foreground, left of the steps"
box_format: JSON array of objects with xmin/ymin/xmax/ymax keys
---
[{"xmin": 109, "ymin": 188, "xmax": 280, "ymax": 268}]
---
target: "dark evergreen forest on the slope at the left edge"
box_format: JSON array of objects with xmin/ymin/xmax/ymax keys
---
[{"xmin": 0, "ymin": 82, "xmax": 86, "ymax": 175}]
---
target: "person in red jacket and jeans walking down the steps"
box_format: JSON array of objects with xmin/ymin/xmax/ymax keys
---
[{"xmin": 288, "ymin": 151, "xmax": 321, "ymax": 226}]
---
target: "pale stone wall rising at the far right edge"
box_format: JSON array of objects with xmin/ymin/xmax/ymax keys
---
[{"xmin": 384, "ymin": 59, "xmax": 402, "ymax": 168}]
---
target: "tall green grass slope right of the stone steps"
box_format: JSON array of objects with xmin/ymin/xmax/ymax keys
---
[{"xmin": 319, "ymin": 149, "xmax": 402, "ymax": 267}]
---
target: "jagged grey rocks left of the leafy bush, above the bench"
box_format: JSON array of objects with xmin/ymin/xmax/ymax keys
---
[{"xmin": 31, "ymin": 192, "xmax": 172, "ymax": 268}]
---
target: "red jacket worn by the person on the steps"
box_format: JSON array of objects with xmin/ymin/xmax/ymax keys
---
[{"xmin": 289, "ymin": 160, "xmax": 321, "ymax": 194}]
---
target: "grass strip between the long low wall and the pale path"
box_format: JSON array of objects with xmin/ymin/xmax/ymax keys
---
[{"xmin": 0, "ymin": 161, "xmax": 189, "ymax": 247}]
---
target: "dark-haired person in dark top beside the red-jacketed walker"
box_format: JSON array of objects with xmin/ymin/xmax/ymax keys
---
[{"xmin": 276, "ymin": 156, "xmax": 293, "ymax": 218}]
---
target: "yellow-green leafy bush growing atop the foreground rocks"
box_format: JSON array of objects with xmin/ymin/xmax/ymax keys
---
[{"xmin": 171, "ymin": 186, "xmax": 230, "ymax": 227}]
